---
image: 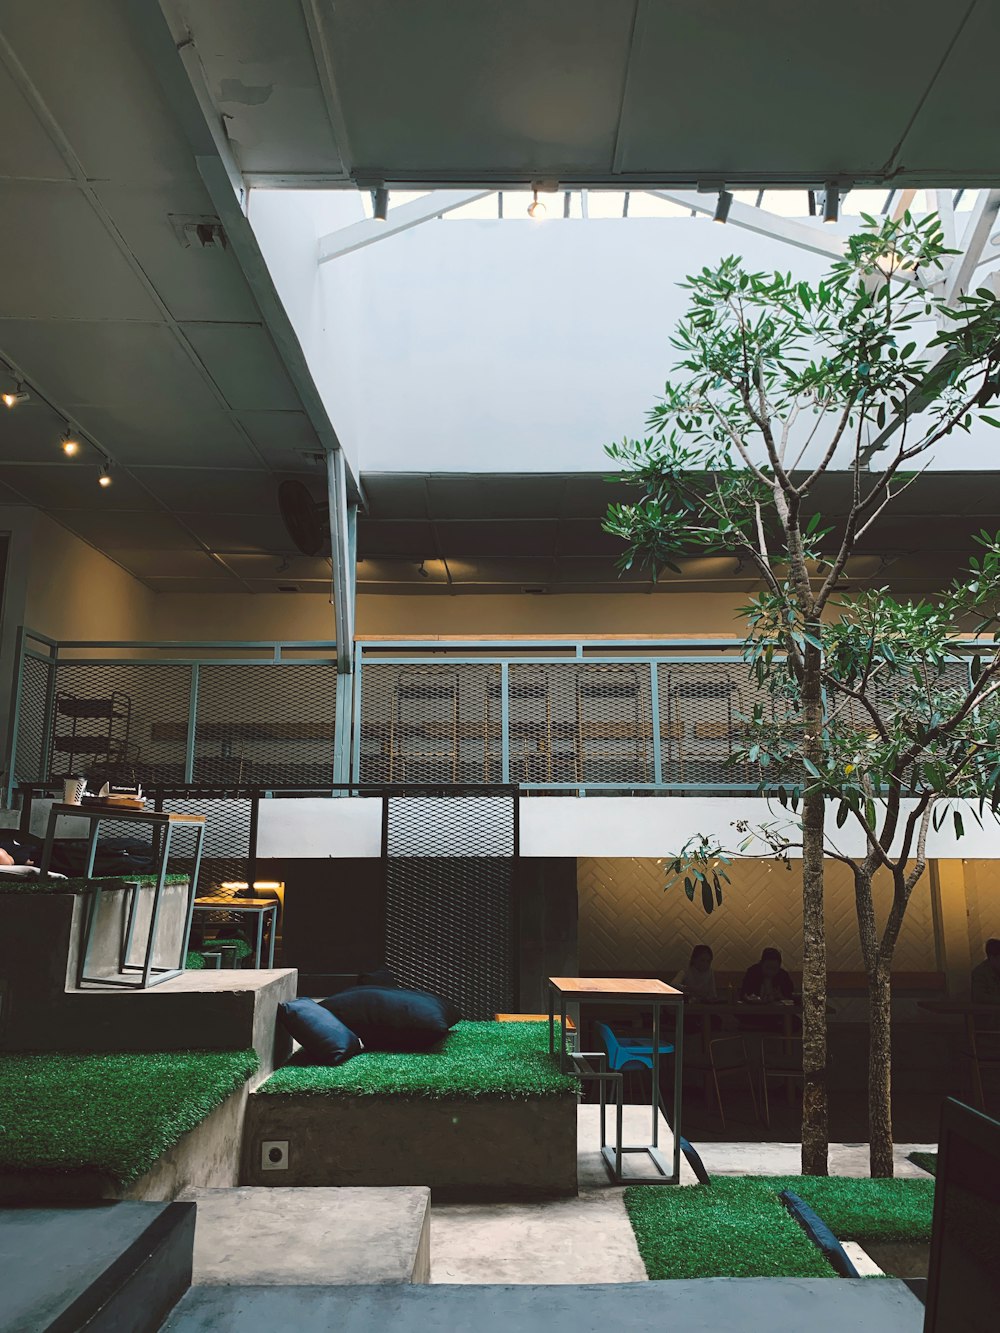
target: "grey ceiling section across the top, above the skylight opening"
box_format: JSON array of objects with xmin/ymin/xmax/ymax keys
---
[{"xmin": 163, "ymin": 0, "xmax": 1000, "ymax": 187}]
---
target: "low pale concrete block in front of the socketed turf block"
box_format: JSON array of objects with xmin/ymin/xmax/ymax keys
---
[{"xmin": 181, "ymin": 1188, "xmax": 431, "ymax": 1286}]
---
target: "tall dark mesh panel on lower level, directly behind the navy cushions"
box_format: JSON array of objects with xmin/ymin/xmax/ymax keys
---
[{"xmin": 384, "ymin": 794, "xmax": 517, "ymax": 1018}]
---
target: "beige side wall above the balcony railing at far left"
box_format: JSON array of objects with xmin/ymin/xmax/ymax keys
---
[{"xmin": 24, "ymin": 513, "xmax": 156, "ymax": 640}]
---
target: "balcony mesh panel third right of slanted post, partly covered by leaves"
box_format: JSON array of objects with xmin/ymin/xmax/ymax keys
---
[{"xmin": 657, "ymin": 661, "xmax": 760, "ymax": 786}]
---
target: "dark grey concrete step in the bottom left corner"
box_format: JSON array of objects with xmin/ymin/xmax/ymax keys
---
[{"xmin": 0, "ymin": 1204, "xmax": 195, "ymax": 1333}]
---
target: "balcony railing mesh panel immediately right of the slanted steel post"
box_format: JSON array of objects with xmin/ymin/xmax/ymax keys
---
[{"xmin": 359, "ymin": 663, "xmax": 500, "ymax": 785}]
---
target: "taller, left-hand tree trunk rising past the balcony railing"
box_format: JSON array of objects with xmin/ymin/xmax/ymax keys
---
[{"xmin": 801, "ymin": 645, "xmax": 829, "ymax": 1176}]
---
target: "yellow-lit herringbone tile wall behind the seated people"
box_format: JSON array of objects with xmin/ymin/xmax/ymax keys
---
[{"xmin": 577, "ymin": 857, "xmax": 944, "ymax": 974}]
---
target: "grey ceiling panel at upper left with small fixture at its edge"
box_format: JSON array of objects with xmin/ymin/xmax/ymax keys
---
[{"xmin": 95, "ymin": 183, "xmax": 260, "ymax": 321}]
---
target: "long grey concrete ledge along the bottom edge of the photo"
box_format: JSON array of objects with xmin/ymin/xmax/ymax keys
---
[{"xmin": 164, "ymin": 1278, "xmax": 924, "ymax": 1333}]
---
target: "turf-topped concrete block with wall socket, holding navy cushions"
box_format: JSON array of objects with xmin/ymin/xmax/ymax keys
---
[{"xmin": 241, "ymin": 1022, "xmax": 579, "ymax": 1200}]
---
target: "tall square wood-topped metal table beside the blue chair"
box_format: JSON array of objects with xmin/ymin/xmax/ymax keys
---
[{"xmin": 548, "ymin": 977, "xmax": 684, "ymax": 1185}]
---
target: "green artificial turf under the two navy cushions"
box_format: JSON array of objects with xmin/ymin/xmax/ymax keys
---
[{"xmin": 257, "ymin": 1022, "xmax": 580, "ymax": 1100}]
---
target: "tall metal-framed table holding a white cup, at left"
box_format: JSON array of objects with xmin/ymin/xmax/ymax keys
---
[{"xmin": 39, "ymin": 801, "xmax": 205, "ymax": 990}]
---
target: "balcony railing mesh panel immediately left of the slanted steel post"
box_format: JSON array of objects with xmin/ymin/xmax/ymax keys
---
[{"xmin": 193, "ymin": 663, "xmax": 337, "ymax": 786}]
